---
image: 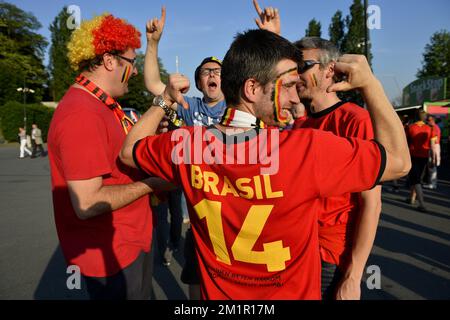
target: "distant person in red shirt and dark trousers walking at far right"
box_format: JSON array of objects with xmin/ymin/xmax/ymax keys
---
[{"xmin": 406, "ymin": 110, "xmax": 437, "ymax": 212}]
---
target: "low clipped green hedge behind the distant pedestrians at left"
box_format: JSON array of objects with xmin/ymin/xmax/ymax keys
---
[{"xmin": 0, "ymin": 101, "xmax": 55, "ymax": 142}]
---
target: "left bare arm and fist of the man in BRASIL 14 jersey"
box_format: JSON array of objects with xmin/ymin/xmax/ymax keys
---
[{"xmin": 120, "ymin": 74, "xmax": 189, "ymax": 168}]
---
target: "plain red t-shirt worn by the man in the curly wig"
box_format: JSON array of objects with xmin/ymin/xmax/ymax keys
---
[{"xmin": 48, "ymin": 88, "xmax": 153, "ymax": 277}]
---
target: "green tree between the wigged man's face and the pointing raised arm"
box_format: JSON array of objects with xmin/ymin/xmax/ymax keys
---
[{"xmin": 118, "ymin": 53, "xmax": 169, "ymax": 113}]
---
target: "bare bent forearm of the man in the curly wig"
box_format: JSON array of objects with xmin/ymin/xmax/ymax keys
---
[{"xmin": 67, "ymin": 177, "xmax": 173, "ymax": 220}]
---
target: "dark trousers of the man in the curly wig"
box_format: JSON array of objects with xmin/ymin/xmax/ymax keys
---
[{"xmin": 84, "ymin": 251, "xmax": 154, "ymax": 300}]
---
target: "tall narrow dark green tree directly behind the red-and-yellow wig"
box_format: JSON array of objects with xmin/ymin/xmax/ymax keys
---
[{"xmin": 48, "ymin": 7, "xmax": 76, "ymax": 101}]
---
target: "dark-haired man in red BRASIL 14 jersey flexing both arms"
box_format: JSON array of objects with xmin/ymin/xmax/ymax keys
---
[{"xmin": 120, "ymin": 30, "xmax": 410, "ymax": 299}]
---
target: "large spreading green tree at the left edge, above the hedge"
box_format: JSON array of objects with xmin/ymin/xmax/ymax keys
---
[{"xmin": 0, "ymin": 2, "xmax": 48, "ymax": 105}]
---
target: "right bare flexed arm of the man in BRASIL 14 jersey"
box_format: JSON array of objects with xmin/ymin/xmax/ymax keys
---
[{"xmin": 328, "ymin": 55, "xmax": 411, "ymax": 181}]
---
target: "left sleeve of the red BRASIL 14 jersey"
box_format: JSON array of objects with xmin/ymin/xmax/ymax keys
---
[{"xmin": 133, "ymin": 132, "xmax": 179, "ymax": 183}]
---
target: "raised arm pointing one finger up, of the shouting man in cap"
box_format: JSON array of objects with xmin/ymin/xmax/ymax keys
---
[{"xmin": 144, "ymin": 6, "xmax": 166, "ymax": 96}]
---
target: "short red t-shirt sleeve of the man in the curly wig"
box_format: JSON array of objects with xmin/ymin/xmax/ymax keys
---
[{"xmin": 58, "ymin": 112, "xmax": 113, "ymax": 181}]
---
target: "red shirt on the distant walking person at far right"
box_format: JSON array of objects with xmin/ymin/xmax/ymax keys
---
[{"xmin": 406, "ymin": 121, "xmax": 436, "ymax": 158}]
